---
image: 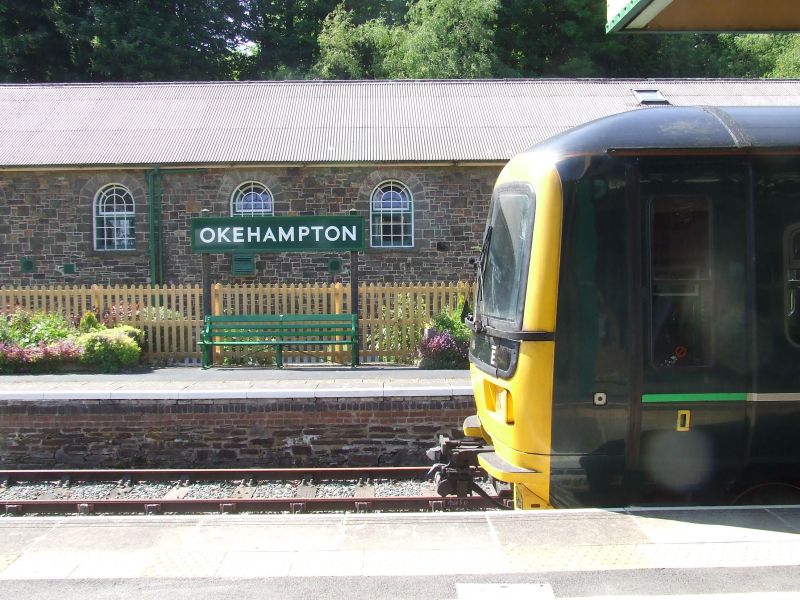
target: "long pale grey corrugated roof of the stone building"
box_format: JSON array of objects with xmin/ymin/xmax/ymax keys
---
[{"xmin": 0, "ymin": 79, "xmax": 800, "ymax": 167}]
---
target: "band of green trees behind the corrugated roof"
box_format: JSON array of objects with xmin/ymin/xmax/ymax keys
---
[{"xmin": 0, "ymin": 0, "xmax": 800, "ymax": 82}]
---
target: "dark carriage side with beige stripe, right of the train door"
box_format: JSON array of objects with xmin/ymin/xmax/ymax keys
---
[{"xmin": 739, "ymin": 156, "xmax": 800, "ymax": 503}]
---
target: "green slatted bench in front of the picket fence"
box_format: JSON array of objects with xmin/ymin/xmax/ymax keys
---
[{"xmin": 199, "ymin": 314, "xmax": 358, "ymax": 369}]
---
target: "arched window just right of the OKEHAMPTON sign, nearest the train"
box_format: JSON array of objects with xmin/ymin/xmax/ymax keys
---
[{"xmin": 369, "ymin": 179, "xmax": 414, "ymax": 248}]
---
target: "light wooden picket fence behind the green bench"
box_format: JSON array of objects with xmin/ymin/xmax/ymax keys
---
[{"xmin": 0, "ymin": 282, "xmax": 470, "ymax": 364}]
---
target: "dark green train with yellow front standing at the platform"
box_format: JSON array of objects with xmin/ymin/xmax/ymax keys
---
[{"xmin": 428, "ymin": 106, "xmax": 800, "ymax": 509}]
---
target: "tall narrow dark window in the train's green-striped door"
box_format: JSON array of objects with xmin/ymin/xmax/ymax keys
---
[{"xmin": 650, "ymin": 196, "xmax": 713, "ymax": 368}]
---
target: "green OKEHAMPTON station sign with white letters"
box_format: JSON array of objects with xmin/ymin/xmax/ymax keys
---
[{"xmin": 191, "ymin": 215, "xmax": 364, "ymax": 254}]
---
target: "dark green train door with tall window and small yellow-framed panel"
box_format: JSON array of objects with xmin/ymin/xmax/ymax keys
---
[{"xmin": 628, "ymin": 158, "xmax": 750, "ymax": 502}]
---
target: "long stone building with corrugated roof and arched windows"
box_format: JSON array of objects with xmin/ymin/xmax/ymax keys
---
[{"xmin": 0, "ymin": 80, "xmax": 800, "ymax": 286}]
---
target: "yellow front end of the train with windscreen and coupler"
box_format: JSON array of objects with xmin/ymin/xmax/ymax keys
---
[{"xmin": 428, "ymin": 153, "xmax": 562, "ymax": 509}]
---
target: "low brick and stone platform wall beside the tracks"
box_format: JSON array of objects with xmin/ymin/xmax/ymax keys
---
[{"xmin": 0, "ymin": 396, "xmax": 475, "ymax": 469}]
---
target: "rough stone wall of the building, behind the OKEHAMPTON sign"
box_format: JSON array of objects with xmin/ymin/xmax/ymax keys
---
[{"xmin": 0, "ymin": 166, "xmax": 500, "ymax": 286}]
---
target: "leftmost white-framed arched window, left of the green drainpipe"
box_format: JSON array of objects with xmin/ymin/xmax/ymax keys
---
[{"xmin": 94, "ymin": 183, "xmax": 136, "ymax": 250}]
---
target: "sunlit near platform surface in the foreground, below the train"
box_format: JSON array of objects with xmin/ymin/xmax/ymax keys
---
[{"xmin": 0, "ymin": 507, "xmax": 800, "ymax": 600}]
